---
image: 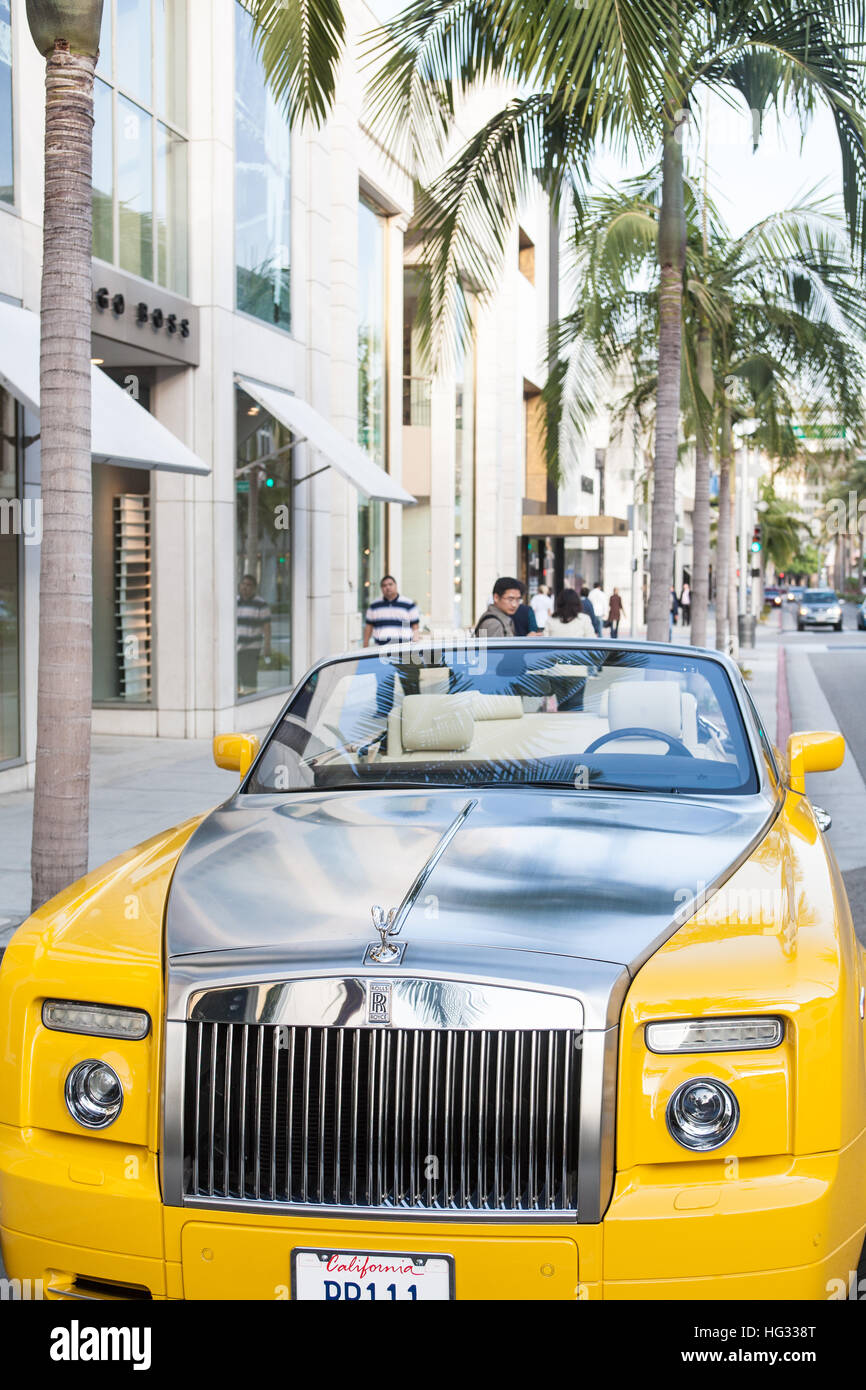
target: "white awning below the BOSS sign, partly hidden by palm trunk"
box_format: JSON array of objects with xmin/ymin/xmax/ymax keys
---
[{"xmin": 0, "ymin": 302, "xmax": 210, "ymax": 474}]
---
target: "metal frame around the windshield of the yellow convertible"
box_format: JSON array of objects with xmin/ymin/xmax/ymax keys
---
[{"xmin": 236, "ymin": 637, "xmax": 777, "ymax": 802}]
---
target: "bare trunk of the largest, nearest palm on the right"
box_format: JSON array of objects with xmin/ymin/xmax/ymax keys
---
[{"xmin": 646, "ymin": 121, "xmax": 685, "ymax": 642}]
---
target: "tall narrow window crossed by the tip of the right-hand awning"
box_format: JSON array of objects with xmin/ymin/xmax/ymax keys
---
[{"xmin": 357, "ymin": 197, "xmax": 388, "ymax": 613}]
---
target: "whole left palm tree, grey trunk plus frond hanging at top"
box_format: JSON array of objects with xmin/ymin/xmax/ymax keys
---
[{"xmin": 26, "ymin": 0, "xmax": 345, "ymax": 909}]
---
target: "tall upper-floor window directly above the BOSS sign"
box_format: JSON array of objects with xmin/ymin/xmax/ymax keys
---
[{"xmin": 93, "ymin": 0, "xmax": 189, "ymax": 295}]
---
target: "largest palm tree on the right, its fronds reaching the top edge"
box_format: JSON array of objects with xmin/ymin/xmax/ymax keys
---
[{"xmin": 371, "ymin": 0, "xmax": 866, "ymax": 641}]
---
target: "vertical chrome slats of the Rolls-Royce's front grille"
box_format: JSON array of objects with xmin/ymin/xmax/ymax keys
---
[{"xmin": 183, "ymin": 1022, "xmax": 581, "ymax": 1212}]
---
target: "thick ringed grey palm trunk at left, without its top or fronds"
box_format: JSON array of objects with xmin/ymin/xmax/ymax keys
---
[{"xmin": 32, "ymin": 42, "xmax": 96, "ymax": 908}]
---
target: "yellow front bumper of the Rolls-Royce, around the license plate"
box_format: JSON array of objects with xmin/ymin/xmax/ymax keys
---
[{"xmin": 0, "ymin": 1126, "xmax": 866, "ymax": 1301}]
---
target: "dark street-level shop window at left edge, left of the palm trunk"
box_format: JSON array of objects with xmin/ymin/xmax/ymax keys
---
[{"xmin": 0, "ymin": 386, "xmax": 22, "ymax": 763}]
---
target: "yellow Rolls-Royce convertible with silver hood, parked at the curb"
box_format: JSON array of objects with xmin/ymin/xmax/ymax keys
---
[{"xmin": 0, "ymin": 639, "xmax": 866, "ymax": 1302}]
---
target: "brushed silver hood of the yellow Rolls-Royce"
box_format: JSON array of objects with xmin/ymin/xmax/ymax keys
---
[{"xmin": 165, "ymin": 788, "xmax": 777, "ymax": 1028}]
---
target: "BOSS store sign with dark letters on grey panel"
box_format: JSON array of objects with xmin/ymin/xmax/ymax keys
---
[{"xmin": 90, "ymin": 261, "xmax": 199, "ymax": 367}]
